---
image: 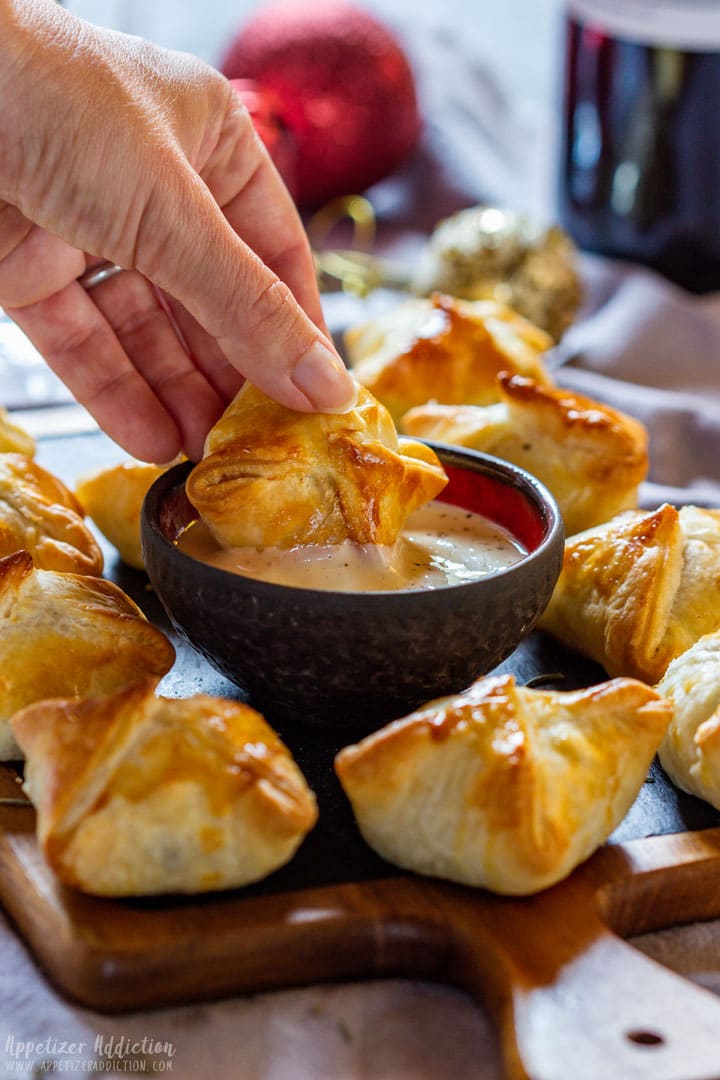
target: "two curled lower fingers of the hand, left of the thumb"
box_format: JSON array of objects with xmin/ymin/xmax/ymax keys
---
[{"xmin": 0, "ymin": 213, "xmax": 197, "ymax": 461}]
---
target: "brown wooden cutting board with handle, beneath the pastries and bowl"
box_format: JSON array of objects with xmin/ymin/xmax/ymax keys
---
[{"xmin": 0, "ymin": 425, "xmax": 720, "ymax": 1080}]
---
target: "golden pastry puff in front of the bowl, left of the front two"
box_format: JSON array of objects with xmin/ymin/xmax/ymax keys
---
[{"xmin": 13, "ymin": 680, "xmax": 317, "ymax": 896}]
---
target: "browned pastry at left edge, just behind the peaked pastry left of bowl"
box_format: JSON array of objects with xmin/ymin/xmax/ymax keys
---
[{"xmin": 0, "ymin": 454, "xmax": 103, "ymax": 573}]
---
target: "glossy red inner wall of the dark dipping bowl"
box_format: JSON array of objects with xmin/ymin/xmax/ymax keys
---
[{"xmin": 436, "ymin": 462, "xmax": 546, "ymax": 551}]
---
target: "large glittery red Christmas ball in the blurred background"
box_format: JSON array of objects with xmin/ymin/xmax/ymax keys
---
[{"xmin": 222, "ymin": 0, "xmax": 420, "ymax": 207}]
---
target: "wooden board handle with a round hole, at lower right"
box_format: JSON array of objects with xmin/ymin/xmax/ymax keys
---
[{"xmin": 425, "ymin": 861, "xmax": 720, "ymax": 1080}]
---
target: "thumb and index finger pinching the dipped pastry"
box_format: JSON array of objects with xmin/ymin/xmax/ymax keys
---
[{"xmin": 137, "ymin": 106, "xmax": 355, "ymax": 411}]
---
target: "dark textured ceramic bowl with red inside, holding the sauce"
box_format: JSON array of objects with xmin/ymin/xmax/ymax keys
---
[{"xmin": 141, "ymin": 444, "xmax": 563, "ymax": 730}]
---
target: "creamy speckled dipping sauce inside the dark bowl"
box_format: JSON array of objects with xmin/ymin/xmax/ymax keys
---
[{"xmin": 176, "ymin": 502, "xmax": 527, "ymax": 593}]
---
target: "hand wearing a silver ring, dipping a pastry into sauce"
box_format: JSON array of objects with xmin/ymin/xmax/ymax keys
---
[{"xmin": 0, "ymin": 0, "xmax": 354, "ymax": 462}]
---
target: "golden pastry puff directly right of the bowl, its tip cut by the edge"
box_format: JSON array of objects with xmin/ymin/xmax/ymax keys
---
[{"xmin": 538, "ymin": 503, "xmax": 720, "ymax": 684}]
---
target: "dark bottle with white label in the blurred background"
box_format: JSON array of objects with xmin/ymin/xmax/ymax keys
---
[{"xmin": 558, "ymin": 0, "xmax": 720, "ymax": 292}]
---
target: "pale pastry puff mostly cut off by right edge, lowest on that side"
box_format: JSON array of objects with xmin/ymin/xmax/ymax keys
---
[{"xmin": 655, "ymin": 630, "xmax": 720, "ymax": 810}]
